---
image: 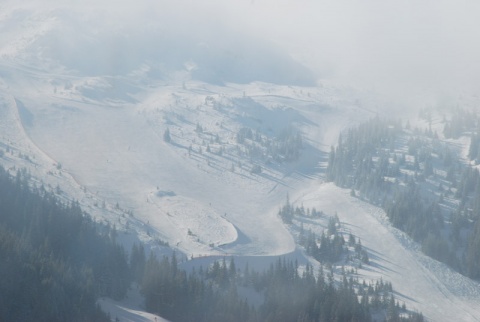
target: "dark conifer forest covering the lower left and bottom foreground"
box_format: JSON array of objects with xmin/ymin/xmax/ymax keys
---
[{"xmin": 0, "ymin": 168, "xmax": 423, "ymax": 321}]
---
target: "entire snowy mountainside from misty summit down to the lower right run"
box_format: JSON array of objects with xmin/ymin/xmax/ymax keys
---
[{"xmin": 0, "ymin": 1, "xmax": 480, "ymax": 321}]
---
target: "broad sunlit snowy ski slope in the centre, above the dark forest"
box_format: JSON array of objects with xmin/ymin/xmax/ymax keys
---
[{"xmin": 0, "ymin": 68, "xmax": 368, "ymax": 255}]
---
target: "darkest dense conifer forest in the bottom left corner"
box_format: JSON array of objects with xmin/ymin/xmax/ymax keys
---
[{"xmin": 0, "ymin": 167, "xmax": 130, "ymax": 321}]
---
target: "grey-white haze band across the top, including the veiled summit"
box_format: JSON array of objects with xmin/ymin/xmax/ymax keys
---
[{"xmin": 0, "ymin": 0, "xmax": 480, "ymax": 107}]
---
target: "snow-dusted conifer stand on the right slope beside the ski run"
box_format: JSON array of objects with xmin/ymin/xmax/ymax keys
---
[{"xmin": 326, "ymin": 115, "xmax": 480, "ymax": 279}]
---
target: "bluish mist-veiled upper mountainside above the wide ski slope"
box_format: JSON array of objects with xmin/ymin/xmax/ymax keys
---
[{"xmin": 2, "ymin": 1, "xmax": 316, "ymax": 85}]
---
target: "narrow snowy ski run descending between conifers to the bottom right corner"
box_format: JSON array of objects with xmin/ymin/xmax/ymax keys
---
[{"xmin": 290, "ymin": 183, "xmax": 480, "ymax": 321}]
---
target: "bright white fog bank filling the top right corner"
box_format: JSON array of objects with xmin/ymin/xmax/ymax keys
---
[{"xmin": 244, "ymin": 0, "xmax": 480, "ymax": 104}]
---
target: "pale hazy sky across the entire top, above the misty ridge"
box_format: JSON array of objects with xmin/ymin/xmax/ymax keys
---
[{"xmin": 0, "ymin": 0, "xmax": 480, "ymax": 108}]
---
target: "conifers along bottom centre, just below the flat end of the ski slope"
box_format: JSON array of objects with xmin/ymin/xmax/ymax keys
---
[{"xmin": 141, "ymin": 255, "xmax": 424, "ymax": 322}]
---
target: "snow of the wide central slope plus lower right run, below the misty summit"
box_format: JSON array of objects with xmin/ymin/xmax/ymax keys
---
[{"xmin": 1, "ymin": 75, "xmax": 480, "ymax": 321}]
